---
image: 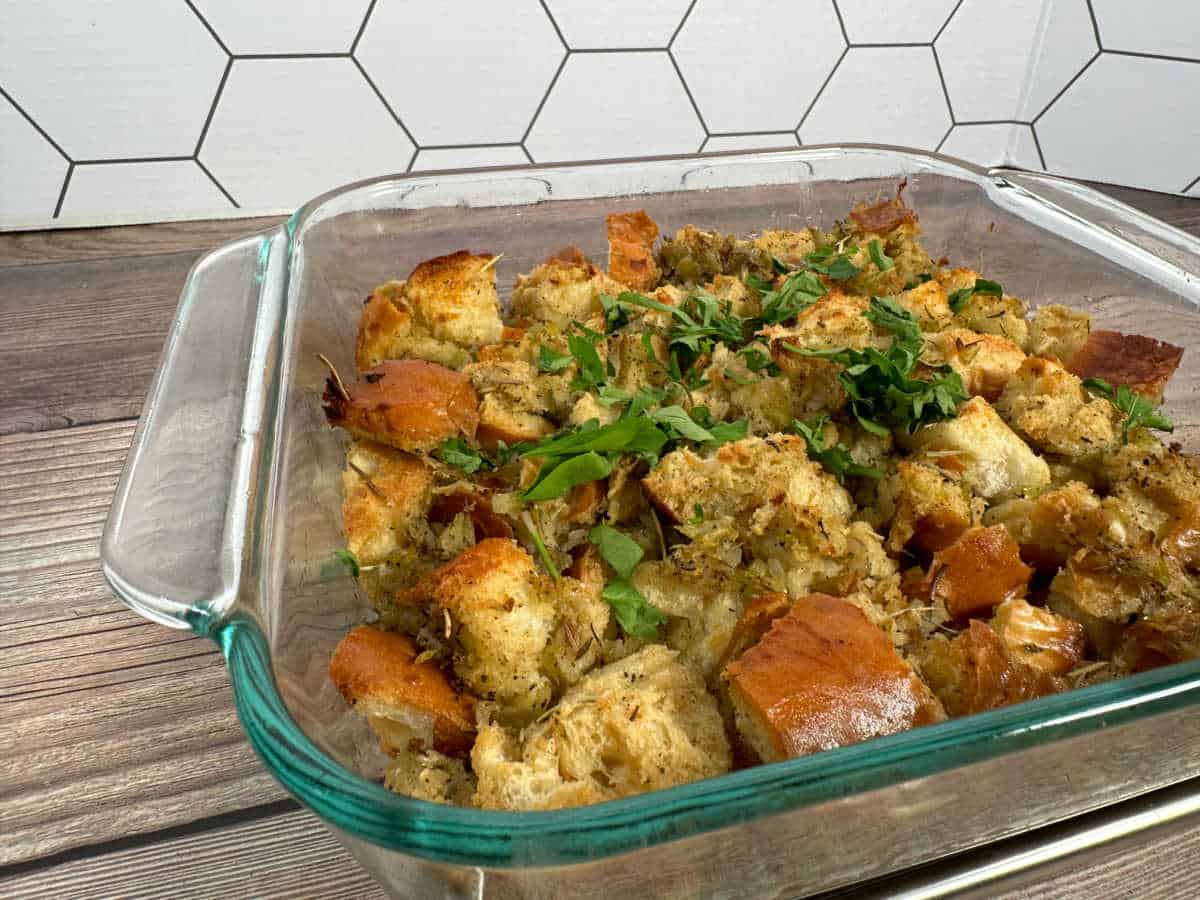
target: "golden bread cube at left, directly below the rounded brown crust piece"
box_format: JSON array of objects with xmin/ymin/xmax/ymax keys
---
[{"xmin": 342, "ymin": 440, "xmax": 433, "ymax": 568}]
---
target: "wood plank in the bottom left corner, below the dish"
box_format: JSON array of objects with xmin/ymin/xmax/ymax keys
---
[{"xmin": 0, "ymin": 810, "xmax": 385, "ymax": 900}]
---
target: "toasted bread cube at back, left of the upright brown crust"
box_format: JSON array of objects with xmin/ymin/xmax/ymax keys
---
[{"xmin": 512, "ymin": 247, "xmax": 626, "ymax": 328}]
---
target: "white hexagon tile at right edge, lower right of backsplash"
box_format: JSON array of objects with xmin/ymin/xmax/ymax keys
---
[{"xmin": 1036, "ymin": 53, "xmax": 1200, "ymax": 191}]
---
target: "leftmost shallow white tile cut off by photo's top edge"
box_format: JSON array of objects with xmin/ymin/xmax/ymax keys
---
[{"xmin": 192, "ymin": 0, "xmax": 371, "ymax": 54}]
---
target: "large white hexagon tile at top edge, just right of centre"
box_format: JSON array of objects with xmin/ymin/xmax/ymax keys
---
[{"xmin": 671, "ymin": 0, "xmax": 846, "ymax": 132}]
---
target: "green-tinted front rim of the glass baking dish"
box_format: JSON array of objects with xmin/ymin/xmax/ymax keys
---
[{"xmin": 211, "ymin": 613, "xmax": 1200, "ymax": 868}]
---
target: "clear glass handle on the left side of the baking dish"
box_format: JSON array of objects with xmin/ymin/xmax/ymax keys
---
[{"xmin": 100, "ymin": 228, "xmax": 288, "ymax": 634}]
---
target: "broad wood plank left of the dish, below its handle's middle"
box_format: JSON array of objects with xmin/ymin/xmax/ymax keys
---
[{"xmin": 0, "ymin": 422, "xmax": 286, "ymax": 864}]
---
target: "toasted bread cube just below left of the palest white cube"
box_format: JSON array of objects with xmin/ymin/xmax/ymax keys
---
[{"xmin": 881, "ymin": 460, "xmax": 977, "ymax": 553}]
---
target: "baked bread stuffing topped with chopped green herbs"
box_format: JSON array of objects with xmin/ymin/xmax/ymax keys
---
[{"xmin": 324, "ymin": 196, "xmax": 1200, "ymax": 810}]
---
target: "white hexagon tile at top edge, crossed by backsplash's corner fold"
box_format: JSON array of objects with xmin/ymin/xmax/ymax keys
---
[{"xmin": 936, "ymin": 0, "xmax": 1097, "ymax": 122}]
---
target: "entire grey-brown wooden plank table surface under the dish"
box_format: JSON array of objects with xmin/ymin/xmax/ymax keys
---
[{"xmin": 7, "ymin": 188, "xmax": 1200, "ymax": 898}]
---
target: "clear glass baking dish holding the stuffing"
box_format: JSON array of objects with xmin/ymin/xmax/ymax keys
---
[{"xmin": 102, "ymin": 145, "xmax": 1200, "ymax": 898}]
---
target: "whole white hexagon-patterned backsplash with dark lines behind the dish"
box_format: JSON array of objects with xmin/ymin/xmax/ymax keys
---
[{"xmin": 0, "ymin": 0, "xmax": 1200, "ymax": 228}]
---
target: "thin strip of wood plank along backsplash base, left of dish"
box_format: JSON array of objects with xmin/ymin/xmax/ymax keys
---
[{"xmin": 0, "ymin": 216, "xmax": 286, "ymax": 269}]
